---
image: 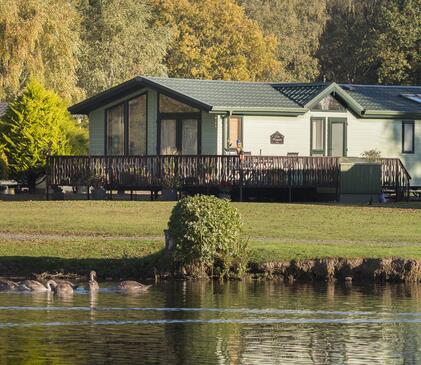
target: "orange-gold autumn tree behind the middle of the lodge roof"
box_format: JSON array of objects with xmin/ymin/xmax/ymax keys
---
[{"xmin": 150, "ymin": 0, "xmax": 280, "ymax": 81}]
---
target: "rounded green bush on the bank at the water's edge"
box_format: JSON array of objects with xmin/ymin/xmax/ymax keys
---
[{"xmin": 168, "ymin": 195, "xmax": 248, "ymax": 278}]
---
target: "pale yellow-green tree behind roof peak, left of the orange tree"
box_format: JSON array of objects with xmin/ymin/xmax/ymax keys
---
[{"xmin": 78, "ymin": 0, "xmax": 170, "ymax": 95}]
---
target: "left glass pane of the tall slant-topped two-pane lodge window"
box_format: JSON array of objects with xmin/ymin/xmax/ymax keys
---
[{"xmin": 107, "ymin": 104, "xmax": 124, "ymax": 155}]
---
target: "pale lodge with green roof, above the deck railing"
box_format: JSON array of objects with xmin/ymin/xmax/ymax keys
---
[{"xmin": 69, "ymin": 77, "xmax": 421, "ymax": 186}]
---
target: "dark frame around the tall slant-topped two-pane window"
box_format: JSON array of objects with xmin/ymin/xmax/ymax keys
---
[{"xmin": 104, "ymin": 91, "xmax": 149, "ymax": 156}]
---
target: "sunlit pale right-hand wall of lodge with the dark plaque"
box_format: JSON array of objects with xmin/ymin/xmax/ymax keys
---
[{"xmin": 238, "ymin": 111, "xmax": 421, "ymax": 186}]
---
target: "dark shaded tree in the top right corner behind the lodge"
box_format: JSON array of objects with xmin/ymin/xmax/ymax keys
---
[{"xmin": 318, "ymin": 0, "xmax": 421, "ymax": 85}]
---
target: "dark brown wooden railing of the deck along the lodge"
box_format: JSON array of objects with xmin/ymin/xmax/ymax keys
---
[{"xmin": 47, "ymin": 155, "xmax": 410, "ymax": 199}]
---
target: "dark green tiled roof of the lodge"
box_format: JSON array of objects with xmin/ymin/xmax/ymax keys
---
[{"xmin": 69, "ymin": 77, "xmax": 421, "ymax": 117}]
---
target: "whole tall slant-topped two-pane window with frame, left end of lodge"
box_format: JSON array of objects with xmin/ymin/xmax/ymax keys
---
[{"xmin": 106, "ymin": 94, "xmax": 147, "ymax": 155}]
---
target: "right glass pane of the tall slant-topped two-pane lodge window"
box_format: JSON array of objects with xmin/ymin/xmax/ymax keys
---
[{"xmin": 128, "ymin": 94, "xmax": 147, "ymax": 155}]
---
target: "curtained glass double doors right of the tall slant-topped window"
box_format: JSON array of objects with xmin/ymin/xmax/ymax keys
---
[{"xmin": 159, "ymin": 118, "xmax": 199, "ymax": 155}]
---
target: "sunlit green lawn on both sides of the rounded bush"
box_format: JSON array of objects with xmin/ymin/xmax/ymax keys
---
[{"xmin": 0, "ymin": 201, "xmax": 421, "ymax": 270}]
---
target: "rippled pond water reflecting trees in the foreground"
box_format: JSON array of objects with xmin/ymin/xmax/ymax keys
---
[{"xmin": 0, "ymin": 282, "xmax": 421, "ymax": 365}]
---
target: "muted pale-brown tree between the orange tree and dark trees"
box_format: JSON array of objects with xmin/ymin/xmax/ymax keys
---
[{"xmin": 239, "ymin": 0, "xmax": 327, "ymax": 82}]
